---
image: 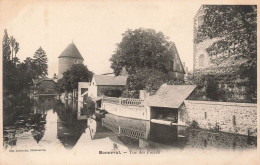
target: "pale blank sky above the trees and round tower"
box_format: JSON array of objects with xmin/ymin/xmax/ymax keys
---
[{"xmin": 1, "ymin": 1, "xmax": 201, "ymax": 77}]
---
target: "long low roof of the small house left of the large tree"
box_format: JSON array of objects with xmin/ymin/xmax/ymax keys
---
[{"xmin": 93, "ymin": 75, "xmax": 127, "ymax": 86}]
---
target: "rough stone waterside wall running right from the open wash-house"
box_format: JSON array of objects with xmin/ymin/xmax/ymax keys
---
[{"xmin": 178, "ymin": 100, "xmax": 257, "ymax": 136}]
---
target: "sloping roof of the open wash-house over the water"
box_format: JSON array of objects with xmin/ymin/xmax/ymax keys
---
[{"xmin": 148, "ymin": 85, "xmax": 196, "ymax": 108}]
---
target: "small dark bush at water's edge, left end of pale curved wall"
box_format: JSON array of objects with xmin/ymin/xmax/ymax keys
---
[{"xmin": 81, "ymin": 96, "xmax": 95, "ymax": 116}]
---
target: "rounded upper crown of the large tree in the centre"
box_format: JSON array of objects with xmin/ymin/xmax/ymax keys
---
[{"xmin": 110, "ymin": 28, "xmax": 169, "ymax": 75}]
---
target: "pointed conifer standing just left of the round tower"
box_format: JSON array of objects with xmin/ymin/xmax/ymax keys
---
[{"xmin": 33, "ymin": 47, "xmax": 48, "ymax": 78}]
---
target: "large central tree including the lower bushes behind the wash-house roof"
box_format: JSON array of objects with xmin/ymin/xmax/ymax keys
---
[{"xmin": 110, "ymin": 28, "xmax": 187, "ymax": 95}]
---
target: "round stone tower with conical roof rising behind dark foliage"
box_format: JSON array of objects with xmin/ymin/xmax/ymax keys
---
[{"xmin": 58, "ymin": 42, "xmax": 84, "ymax": 79}]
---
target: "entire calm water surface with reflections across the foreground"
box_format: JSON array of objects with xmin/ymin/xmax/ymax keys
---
[{"xmin": 3, "ymin": 97, "xmax": 257, "ymax": 151}]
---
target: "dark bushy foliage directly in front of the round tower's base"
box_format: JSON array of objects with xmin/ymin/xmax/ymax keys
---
[{"xmin": 57, "ymin": 64, "xmax": 93, "ymax": 93}]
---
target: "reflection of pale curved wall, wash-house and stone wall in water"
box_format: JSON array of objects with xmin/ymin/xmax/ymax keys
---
[{"xmin": 102, "ymin": 114, "xmax": 257, "ymax": 150}]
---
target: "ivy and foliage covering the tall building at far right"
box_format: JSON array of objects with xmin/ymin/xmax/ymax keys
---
[{"xmin": 195, "ymin": 5, "xmax": 257, "ymax": 102}]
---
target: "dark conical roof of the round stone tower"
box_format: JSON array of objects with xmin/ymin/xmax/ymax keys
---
[{"xmin": 58, "ymin": 42, "xmax": 84, "ymax": 60}]
